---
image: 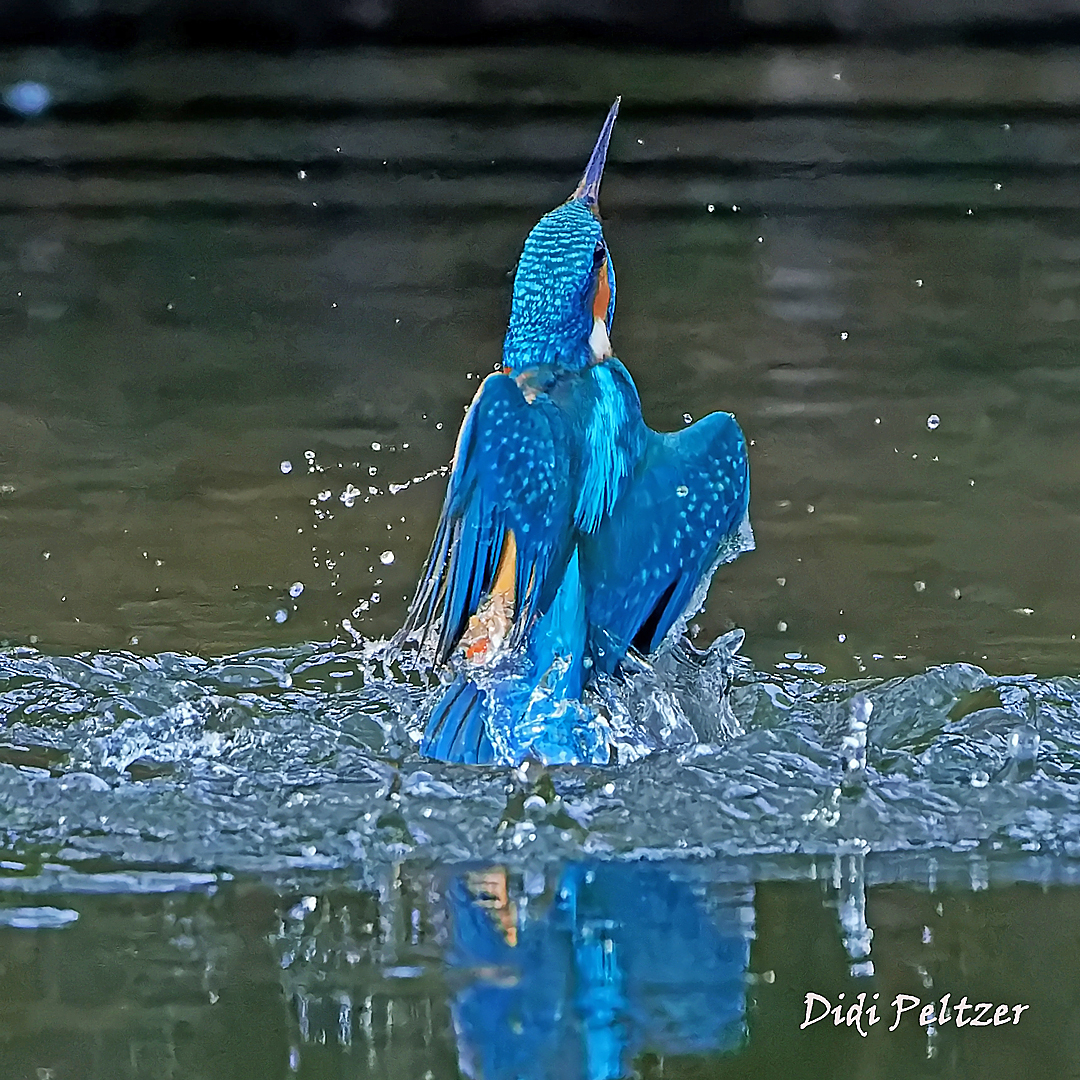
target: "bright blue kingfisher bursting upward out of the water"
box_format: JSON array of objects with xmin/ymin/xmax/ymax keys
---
[{"xmin": 397, "ymin": 98, "xmax": 754, "ymax": 765}]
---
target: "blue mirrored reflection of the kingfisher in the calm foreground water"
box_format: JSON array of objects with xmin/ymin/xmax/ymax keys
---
[{"xmin": 446, "ymin": 863, "xmax": 752, "ymax": 1080}]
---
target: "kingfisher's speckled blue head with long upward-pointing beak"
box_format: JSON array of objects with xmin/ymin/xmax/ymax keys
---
[{"xmin": 502, "ymin": 98, "xmax": 620, "ymax": 372}]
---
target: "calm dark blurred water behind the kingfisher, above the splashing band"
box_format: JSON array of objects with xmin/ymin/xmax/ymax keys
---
[{"xmin": 0, "ymin": 16, "xmax": 1080, "ymax": 677}]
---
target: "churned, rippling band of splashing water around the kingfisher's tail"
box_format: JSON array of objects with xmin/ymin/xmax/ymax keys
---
[{"xmin": 0, "ymin": 632, "xmax": 1080, "ymax": 888}]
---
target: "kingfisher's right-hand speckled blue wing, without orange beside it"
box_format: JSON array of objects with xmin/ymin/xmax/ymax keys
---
[{"xmin": 581, "ymin": 413, "xmax": 754, "ymax": 672}]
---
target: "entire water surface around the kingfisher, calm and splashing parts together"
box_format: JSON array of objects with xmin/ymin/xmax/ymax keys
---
[{"xmin": 0, "ymin": 44, "xmax": 1080, "ymax": 1080}]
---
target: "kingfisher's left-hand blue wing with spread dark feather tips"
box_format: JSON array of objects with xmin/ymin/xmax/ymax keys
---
[{"xmin": 403, "ymin": 375, "xmax": 573, "ymax": 662}]
